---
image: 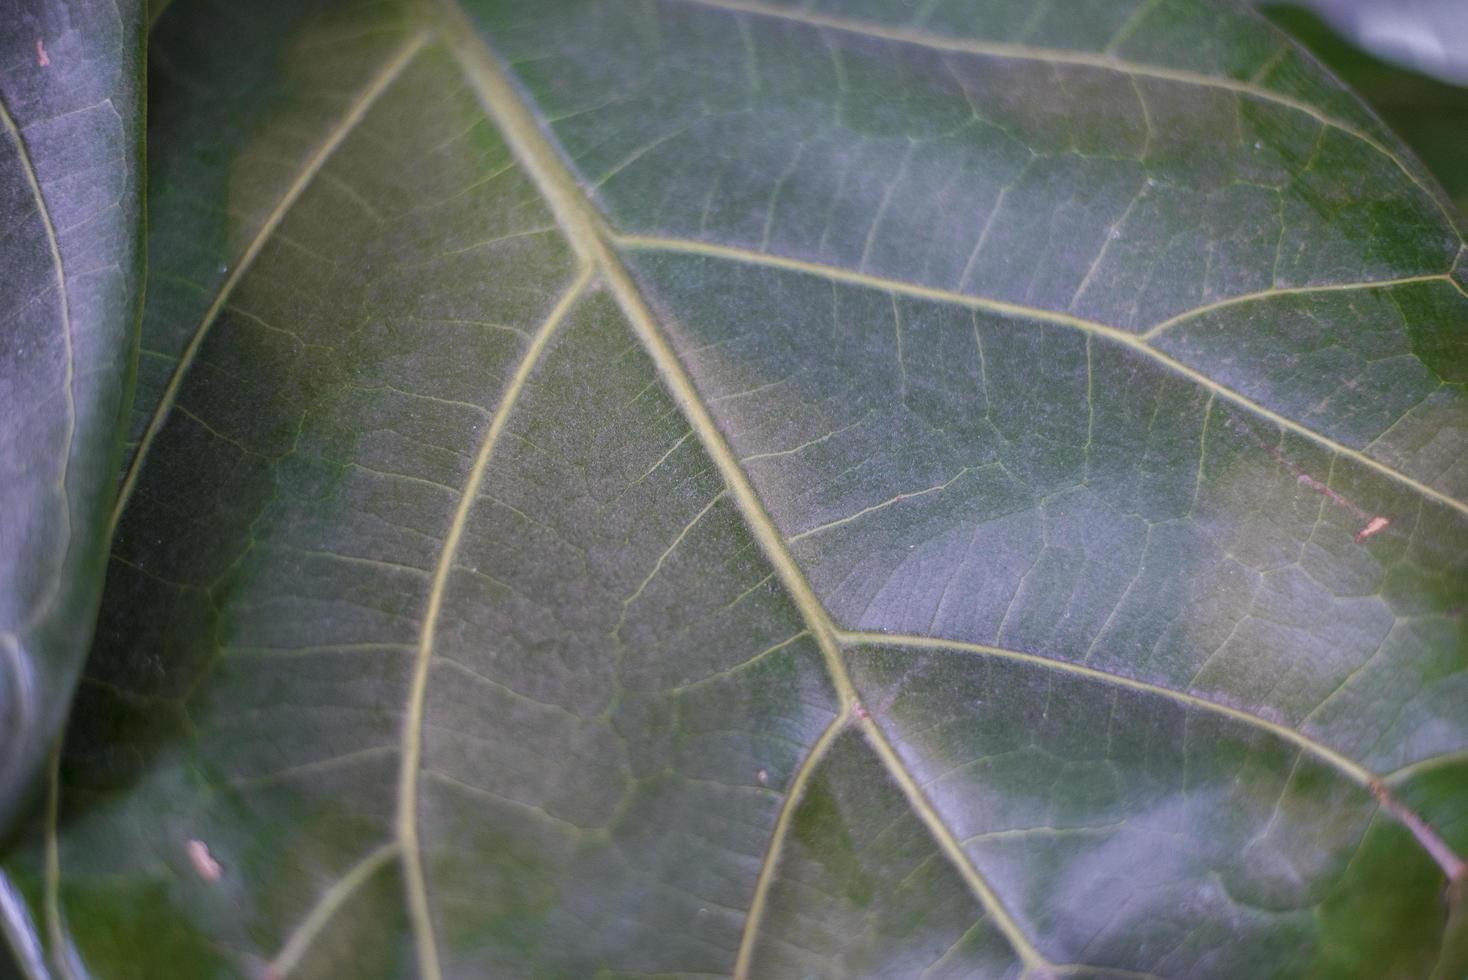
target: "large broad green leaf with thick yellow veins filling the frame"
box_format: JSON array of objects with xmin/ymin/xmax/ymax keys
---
[{"xmin": 2, "ymin": 0, "xmax": 1468, "ymax": 977}]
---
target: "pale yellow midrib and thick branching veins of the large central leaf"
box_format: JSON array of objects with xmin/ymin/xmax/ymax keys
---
[{"xmin": 51, "ymin": 0, "xmax": 1450, "ymax": 980}]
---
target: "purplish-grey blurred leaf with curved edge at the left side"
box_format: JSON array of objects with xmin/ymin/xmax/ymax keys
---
[{"xmin": 0, "ymin": 0, "xmax": 142, "ymax": 832}]
